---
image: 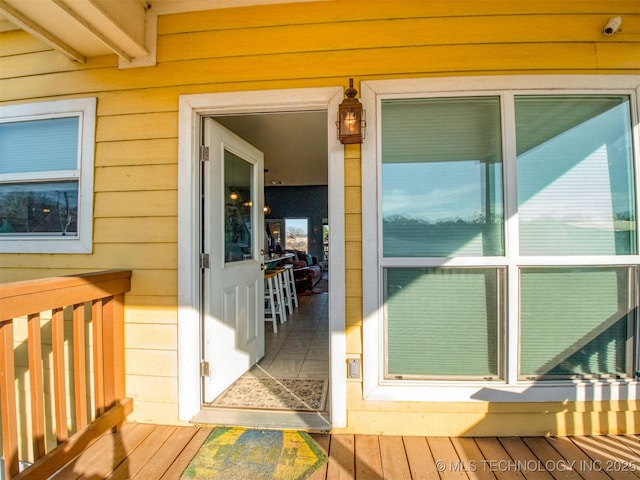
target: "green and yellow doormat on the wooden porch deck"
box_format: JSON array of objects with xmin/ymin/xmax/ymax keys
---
[{"xmin": 180, "ymin": 427, "xmax": 327, "ymax": 480}]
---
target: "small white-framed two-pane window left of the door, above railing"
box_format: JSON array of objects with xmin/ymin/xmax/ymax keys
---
[{"xmin": 0, "ymin": 99, "xmax": 95, "ymax": 253}]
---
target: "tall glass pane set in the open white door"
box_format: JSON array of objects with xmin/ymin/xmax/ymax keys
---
[{"xmin": 224, "ymin": 150, "xmax": 255, "ymax": 262}]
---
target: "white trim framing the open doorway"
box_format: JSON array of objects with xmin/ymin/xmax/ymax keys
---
[{"xmin": 178, "ymin": 87, "xmax": 347, "ymax": 427}]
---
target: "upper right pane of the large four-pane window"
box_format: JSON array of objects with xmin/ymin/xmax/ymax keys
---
[{"xmin": 516, "ymin": 96, "xmax": 637, "ymax": 255}]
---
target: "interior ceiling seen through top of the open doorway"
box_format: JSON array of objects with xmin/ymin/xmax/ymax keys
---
[{"xmin": 214, "ymin": 112, "xmax": 329, "ymax": 187}]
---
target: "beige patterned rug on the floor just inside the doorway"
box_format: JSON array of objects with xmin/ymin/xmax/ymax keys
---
[{"xmin": 210, "ymin": 377, "xmax": 327, "ymax": 411}]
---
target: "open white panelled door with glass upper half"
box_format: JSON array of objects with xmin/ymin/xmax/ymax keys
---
[{"xmin": 205, "ymin": 118, "xmax": 264, "ymax": 403}]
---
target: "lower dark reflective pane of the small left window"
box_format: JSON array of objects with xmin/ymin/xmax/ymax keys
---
[{"xmin": 0, "ymin": 181, "xmax": 78, "ymax": 235}]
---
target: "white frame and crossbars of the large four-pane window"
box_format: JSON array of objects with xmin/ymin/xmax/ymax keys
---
[{"xmin": 361, "ymin": 75, "xmax": 640, "ymax": 402}]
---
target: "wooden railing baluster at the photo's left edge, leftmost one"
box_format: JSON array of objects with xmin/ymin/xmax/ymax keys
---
[{"xmin": 0, "ymin": 320, "xmax": 18, "ymax": 478}]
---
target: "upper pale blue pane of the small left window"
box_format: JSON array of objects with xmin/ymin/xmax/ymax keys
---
[{"xmin": 0, "ymin": 116, "xmax": 79, "ymax": 174}]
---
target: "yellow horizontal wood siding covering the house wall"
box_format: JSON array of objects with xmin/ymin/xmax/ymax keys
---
[{"xmin": 0, "ymin": 0, "xmax": 640, "ymax": 434}]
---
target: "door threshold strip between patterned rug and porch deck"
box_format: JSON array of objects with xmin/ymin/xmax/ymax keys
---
[{"xmin": 191, "ymin": 407, "xmax": 331, "ymax": 433}]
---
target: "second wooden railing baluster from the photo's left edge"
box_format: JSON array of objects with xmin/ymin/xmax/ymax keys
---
[{"xmin": 27, "ymin": 313, "xmax": 46, "ymax": 459}]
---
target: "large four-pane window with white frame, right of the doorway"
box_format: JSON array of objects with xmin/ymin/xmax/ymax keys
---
[{"xmin": 363, "ymin": 79, "xmax": 640, "ymax": 401}]
